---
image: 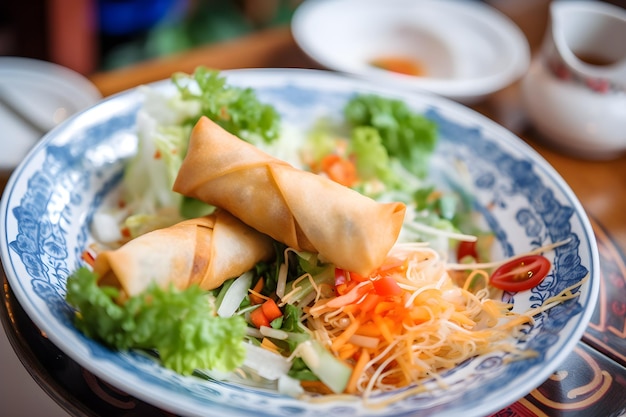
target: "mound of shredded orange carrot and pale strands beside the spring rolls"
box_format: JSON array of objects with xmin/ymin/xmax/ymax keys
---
[{"xmin": 294, "ymin": 244, "xmax": 575, "ymax": 401}]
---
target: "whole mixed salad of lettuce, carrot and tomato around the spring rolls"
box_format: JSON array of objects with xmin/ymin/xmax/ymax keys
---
[{"xmin": 66, "ymin": 68, "xmax": 575, "ymax": 404}]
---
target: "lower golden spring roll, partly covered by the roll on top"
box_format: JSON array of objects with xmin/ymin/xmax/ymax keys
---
[{"xmin": 94, "ymin": 210, "xmax": 274, "ymax": 296}]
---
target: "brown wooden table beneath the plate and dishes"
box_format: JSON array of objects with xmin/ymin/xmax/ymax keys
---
[{"xmin": 3, "ymin": 21, "xmax": 626, "ymax": 416}]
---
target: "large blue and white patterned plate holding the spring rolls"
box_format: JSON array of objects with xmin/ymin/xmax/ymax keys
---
[{"xmin": 0, "ymin": 70, "xmax": 600, "ymax": 417}]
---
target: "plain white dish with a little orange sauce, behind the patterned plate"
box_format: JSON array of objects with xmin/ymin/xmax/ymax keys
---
[{"xmin": 292, "ymin": 0, "xmax": 530, "ymax": 104}]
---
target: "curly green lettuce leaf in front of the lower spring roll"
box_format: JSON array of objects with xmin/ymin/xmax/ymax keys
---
[{"xmin": 65, "ymin": 267, "xmax": 246, "ymax": 375}]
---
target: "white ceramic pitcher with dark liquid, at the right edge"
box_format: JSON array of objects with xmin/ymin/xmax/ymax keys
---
[{"xmin": 522, "ymin": 1, "xmax": 626, "ymax": 159}]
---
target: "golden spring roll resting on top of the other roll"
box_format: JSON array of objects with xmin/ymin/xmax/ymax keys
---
[{"xmin": 174, "ymin": 117, "xmax": 406, "ymax": 275}]
